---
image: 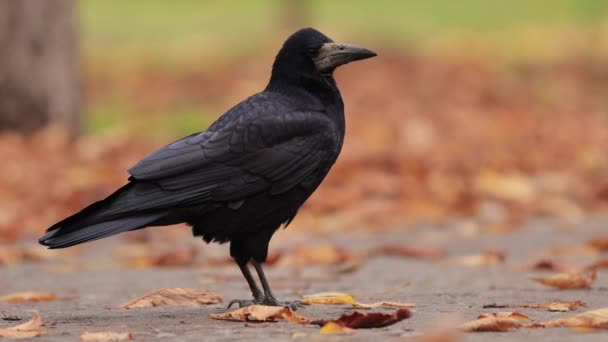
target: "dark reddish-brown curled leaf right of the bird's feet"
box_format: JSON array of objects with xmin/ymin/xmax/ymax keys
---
[{"xmin": 312, "ymin": 309, "xmax": 412, "ymax": 329}]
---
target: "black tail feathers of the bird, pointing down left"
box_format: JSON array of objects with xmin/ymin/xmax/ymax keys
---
[{"xmin": 38, "ymin": 183, "xmax": 166, "ymax": 249}]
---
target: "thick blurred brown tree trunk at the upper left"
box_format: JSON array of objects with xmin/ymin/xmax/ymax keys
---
[{"xmin": 0, "ymin": 0, "xmax": 81, "ymax": 134}]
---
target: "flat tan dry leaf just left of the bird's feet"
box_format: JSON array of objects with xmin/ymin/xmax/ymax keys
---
[{"xmin": 119, "ymin": 287, "xmax": 224, "ymax": 309}]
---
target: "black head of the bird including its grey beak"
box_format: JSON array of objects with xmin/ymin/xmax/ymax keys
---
[{"xmin": 273, "ymin": 28, "xmax": 376, "ymax": 81}]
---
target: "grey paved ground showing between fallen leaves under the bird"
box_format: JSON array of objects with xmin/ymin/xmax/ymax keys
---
[{"xmin": 0, "ymin": 217, "xmax": 608, "ymax": 341}]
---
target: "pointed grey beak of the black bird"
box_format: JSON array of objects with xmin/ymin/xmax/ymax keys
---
[{"xmin": 313, "ymin": 43, "xmax": 377, "ymax": 72}]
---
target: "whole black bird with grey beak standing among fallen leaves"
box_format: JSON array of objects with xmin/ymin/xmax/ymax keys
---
[{"xmin": 39, "ymin": 28, "xmax": 376, "ymax": 307}]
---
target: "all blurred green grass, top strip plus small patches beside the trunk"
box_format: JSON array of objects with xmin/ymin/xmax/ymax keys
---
[{"xmin": 79, "ymin": 0, "xmax": 608, "ymax": 136}]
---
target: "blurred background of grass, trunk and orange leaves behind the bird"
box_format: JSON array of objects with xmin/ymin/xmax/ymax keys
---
[{"xmin": 0, "ymin": 0, "xmax": 608, "ymax": 251}]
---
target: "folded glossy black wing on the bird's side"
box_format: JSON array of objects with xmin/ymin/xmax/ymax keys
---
[{"xmin": 129, "ymin": 111, "xmax": 338, "ymax": 204}]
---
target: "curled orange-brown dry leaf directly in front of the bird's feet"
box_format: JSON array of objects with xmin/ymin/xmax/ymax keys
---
[{"xmin": 209, "ymin": 305, "xmax": 310, "ymax": 324}]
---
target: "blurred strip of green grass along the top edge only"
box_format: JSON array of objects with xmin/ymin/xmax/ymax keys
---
[{"xmin": 80, "ymin": 0, "xmax": 608, "ymax": 62}]
